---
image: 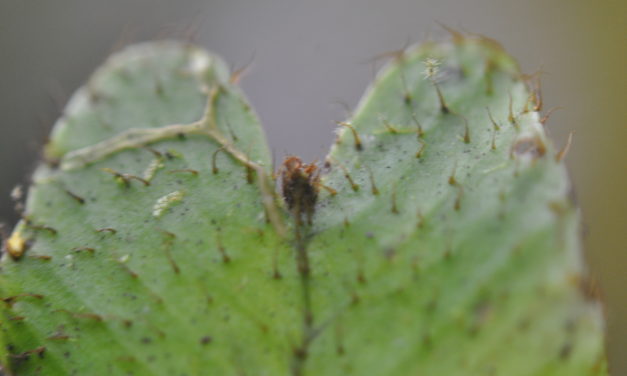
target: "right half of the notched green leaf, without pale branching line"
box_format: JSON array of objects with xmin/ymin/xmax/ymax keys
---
[{"xmin": 309, "ymin": 36, "xmax": 605, "ymax": 375}]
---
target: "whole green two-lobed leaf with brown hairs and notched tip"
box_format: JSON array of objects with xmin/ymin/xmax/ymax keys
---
[{"xmin": 0, "ymin": 35, "xmax": 606, "ymax": 375}]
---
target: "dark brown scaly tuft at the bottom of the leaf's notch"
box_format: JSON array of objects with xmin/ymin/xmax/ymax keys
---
[{"xmin": 281, "ymin": 156, "xmax": 320, "ymax": 224}]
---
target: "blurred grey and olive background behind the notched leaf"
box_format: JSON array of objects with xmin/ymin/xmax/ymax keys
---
[{"xmin": 0, "ymin": 0, "xmax": 627, "ymax": 375}]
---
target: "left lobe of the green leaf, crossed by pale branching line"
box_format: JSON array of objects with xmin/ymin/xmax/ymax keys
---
[{"xmin": 0, "ymin": 43, "xmax": 300, "ymax": 375}]
